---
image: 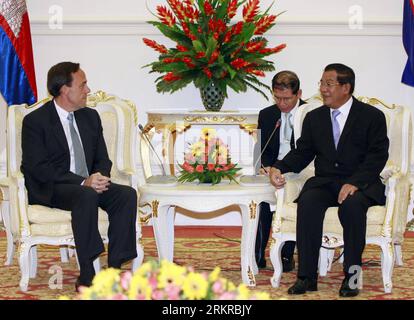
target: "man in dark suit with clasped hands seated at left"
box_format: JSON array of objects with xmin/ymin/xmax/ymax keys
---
[{"xmin": 22, "ymin": 62, "xmax": 137, "ymax": 289}]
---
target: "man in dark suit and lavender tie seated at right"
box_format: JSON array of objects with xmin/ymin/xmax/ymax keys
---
[{"xmin": 270, "ymin": 64, "xmax": 389, "ymax": 297}]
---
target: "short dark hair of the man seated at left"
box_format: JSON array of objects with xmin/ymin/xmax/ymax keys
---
[{"xmin": 47, "ymin": 62, "xmax": 80, "ymax": 98}]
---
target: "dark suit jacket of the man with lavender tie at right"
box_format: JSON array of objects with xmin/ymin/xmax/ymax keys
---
[{"xmin": 274, "ymin": 98, "xmax": 389, "ymax": 205}]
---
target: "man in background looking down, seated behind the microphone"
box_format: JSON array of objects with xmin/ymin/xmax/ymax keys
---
[{"xmin": 255, "ymin": 71, "xmax": 305, "ymax": 272}]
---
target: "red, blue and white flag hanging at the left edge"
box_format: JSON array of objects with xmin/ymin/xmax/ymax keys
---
[{"xmin": 0, "ymin": 0, "xmax": 37, "ymax": 105}]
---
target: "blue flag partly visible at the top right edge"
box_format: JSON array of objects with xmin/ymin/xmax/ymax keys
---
[{"xmin": 401, "ymin": 0, "xmax": 414, "ymax": 87}]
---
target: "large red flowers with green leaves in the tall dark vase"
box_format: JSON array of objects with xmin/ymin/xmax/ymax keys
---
[{"xmin": 143, "ymin": 0, "xmax": 286, "ymax": 99}]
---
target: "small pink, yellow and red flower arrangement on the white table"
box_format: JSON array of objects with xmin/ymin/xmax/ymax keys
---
[{"xmin": 178, "ymin": 128, "xmax": 241, "ymax": 184}]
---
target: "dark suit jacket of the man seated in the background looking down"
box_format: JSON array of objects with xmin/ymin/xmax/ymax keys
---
[{"xmin": 255, "ymin": 100, "xmax": 305, "ymax": 170}]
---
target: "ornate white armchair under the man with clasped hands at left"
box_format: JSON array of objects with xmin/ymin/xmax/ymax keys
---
[{"xmin": 7, "ymin": 91, "xmax": 144, "ymax": 291}]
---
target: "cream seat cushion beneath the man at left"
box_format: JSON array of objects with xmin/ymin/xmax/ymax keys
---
[{"xmin": 27, "ymin": 205, "xmax": 108, "ymax": 224}]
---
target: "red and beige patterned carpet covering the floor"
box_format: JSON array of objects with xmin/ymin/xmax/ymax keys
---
[{"xmin": 0, "ymin": 231, "xmax": 414, "ymax": 300}]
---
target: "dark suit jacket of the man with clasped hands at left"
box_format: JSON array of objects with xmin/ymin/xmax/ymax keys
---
[{"xmin": 21, "ymin": 101, "xmax": 112, "ymax": 206}]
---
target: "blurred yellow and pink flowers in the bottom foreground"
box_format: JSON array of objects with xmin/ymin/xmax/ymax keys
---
[{"xmin": 66, "ymin": 260, "xmax": 270, "ymax": 300}]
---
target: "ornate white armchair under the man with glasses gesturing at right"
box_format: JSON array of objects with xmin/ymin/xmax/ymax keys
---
[{"xmin": 270, "ymin": 97, "xmax": 412, "ymax": 293}]
